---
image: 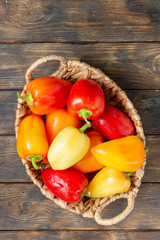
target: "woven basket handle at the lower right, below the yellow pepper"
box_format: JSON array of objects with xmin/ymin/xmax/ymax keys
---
[{"xmin": 94, "ymin": 193, "xmax": 135, "ymax": 226}]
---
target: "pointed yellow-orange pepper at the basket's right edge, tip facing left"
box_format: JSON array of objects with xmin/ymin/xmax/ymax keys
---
[{"xmin": 91, "ymin": 136, "xmax": 145, "ymax": 172}]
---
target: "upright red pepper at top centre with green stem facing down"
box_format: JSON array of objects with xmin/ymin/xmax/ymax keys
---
[{"xmin": 67, "ymin": 79, "xmax": 105, "ymax": 120}]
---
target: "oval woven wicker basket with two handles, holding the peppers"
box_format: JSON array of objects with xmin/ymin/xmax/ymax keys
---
[{"xmin": 15, "ymin": 55, "xmax": 146, "ymax": 226}]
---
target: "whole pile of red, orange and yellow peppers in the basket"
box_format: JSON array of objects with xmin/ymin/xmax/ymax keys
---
[{"xmin": 17, "ymin": 77, "xmax": 145, "ymax": 202}]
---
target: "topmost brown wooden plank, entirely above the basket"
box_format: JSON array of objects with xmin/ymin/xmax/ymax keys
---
[{"xmin": 0, "ymin": 0, "xmax": 160, "ymax": 42}]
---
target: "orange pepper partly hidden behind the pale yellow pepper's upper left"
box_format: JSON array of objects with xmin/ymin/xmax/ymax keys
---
[{"xmin": 45, "ymin": 108, "xmax": 81, "ymax": 145}]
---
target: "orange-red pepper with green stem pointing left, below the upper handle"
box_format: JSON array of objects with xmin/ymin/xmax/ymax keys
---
[{"xmin": 17, "ymin": 77, "xmax": 72, "ymax": 115}]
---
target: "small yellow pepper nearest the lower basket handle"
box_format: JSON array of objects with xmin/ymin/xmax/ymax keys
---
[{"xmin": 87, "ymin": 167, "xmax": 131, "ymax": 198}]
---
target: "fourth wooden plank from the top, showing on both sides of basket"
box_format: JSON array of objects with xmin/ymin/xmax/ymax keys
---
[{"xmin": 0, "ymin": 135, "xmax": 160, "ymax": 183}]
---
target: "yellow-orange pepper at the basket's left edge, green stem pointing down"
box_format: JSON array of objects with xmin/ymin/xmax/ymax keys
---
[{"xmin": 17, "ymin": 114, "xmax": 48, "ymax": 170}]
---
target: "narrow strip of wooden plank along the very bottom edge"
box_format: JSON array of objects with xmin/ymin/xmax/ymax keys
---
[{"xmin": 0, "ymin": 231, "xmax": 160, "ymax": 240}]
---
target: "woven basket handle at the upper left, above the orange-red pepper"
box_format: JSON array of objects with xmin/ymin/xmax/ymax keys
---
[{"xmin": 25, "ymin": 55, "xmax": 67, "ymax": 84}]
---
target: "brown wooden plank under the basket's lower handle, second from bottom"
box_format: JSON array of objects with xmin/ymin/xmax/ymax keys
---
[{"xmin": 0, "ymin": 183, "xmax": 160, "ymax": 230}]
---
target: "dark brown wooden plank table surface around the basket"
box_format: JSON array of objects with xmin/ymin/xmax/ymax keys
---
[{"xmin": 0, "ymin": 0, "xmax": 160, "ymax": 240}]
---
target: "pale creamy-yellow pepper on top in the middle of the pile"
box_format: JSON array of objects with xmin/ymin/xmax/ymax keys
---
[{"xmin": 48, "ymin": 123, "xmax": 91, "ymax": 170}]
